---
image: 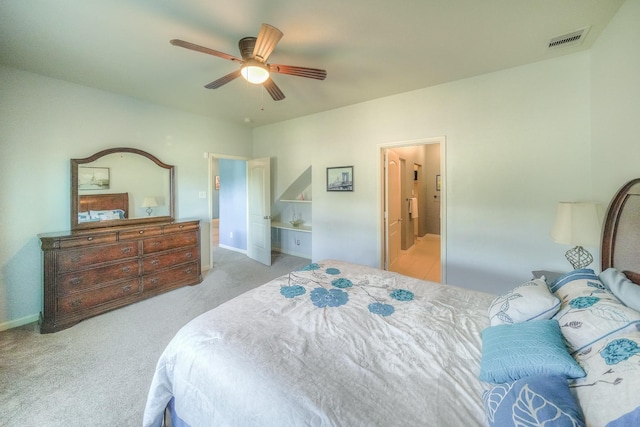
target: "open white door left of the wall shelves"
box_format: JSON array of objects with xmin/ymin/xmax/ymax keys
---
[{"xmin": 247, "ymin": 157, "xmax": 271, "ymax": 265}]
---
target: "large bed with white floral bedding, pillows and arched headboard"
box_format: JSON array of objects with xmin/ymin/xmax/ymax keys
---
[{"xmin": 143, "ymin": 180, "xmax": 640, "ymax": 427}]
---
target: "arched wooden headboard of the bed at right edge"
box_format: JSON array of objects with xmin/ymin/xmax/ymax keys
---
[{"xmin": 602, "ymin": 178, "xmax": 640, "ymax": 285}]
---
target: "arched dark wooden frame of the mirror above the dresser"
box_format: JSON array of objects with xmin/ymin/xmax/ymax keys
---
[{"xmin": 71, "ymin": 147, "xmax": 175, "ymax": 231}]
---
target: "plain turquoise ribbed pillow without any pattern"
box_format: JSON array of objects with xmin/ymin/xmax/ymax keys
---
[{"xmin": 480, "ymin": 320, "xmax": 584, "ymax": 383}]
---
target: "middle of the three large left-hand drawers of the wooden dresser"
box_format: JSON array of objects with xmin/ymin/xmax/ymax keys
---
[{"xmin": 58, "ymin": 260, "xmax": 140, "ymax": 295}]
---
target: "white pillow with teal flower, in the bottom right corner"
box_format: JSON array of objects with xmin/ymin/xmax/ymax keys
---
[{"xmin": 572, "ymin": 331, "xmax": 640, "ymax": 427}]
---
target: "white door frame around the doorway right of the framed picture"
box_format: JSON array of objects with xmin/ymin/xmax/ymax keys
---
[{"xmin": 377, "ymin": 136, "xmax": 447, "ymax": 283}]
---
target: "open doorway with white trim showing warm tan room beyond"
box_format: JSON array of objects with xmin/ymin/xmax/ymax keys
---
[{"xmin": 379, "ymin": 137, "xmax": 446, "ymax": 283}]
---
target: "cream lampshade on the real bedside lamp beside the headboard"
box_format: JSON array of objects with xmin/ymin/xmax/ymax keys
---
[{"xmin": 551, "ymin": 202, "xmax": 601, "ymax": 246}]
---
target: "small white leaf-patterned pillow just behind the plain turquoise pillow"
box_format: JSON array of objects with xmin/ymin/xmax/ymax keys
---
[{"xmin": 489, "ymin": 278, "xmax": 560, "ymax": 326}]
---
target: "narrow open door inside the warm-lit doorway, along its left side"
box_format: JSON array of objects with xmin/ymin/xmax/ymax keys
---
[{"xmin": 384, "ymin": 150, "xmax": 402, "ymax": 271}]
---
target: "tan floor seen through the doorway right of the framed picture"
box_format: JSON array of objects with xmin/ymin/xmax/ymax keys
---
[{"xmin": 396, "ymin": 234, "xmax": 440, "ymax": 283}]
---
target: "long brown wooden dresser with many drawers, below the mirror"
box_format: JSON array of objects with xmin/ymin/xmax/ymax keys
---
[{"xmin": 38, "ymin": 221, "xmax": 202, "ymax": 333}]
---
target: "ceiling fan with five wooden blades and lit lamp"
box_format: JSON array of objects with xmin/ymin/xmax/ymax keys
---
[{"xmin": 170, "ymin": 24, "xmax": 327, "ymax": 101}]
